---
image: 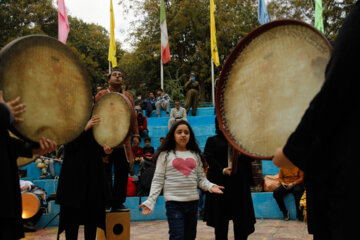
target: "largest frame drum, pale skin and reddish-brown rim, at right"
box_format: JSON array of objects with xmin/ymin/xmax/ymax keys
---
[{"xmin": 216, "ymin": 20, "xmax": 331, "ymax": 159}]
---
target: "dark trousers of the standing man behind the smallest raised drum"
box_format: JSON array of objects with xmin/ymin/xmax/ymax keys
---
[{"xmin": 105, "ymin": 148, "xmax": 129, "ymax": 209}]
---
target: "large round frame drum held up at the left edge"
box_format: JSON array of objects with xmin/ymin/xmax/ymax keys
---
[{"xmin": 0, "ymin": 35, "xmax": 92, "ymax": 145}]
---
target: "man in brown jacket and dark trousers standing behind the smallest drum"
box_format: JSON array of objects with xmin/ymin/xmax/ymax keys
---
[{"xmin": 95, "ymin": 69, "xmax": 139, "ymax": 211}]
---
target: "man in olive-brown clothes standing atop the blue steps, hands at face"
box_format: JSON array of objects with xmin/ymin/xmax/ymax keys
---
[{"xmin": 185, "ymin": 73, "xmax": 199, "ymax": 116}]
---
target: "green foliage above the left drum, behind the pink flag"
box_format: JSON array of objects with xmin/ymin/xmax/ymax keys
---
[{"xmin": 0, "ymin": 0, "xmax": 124, "ymax": 93}]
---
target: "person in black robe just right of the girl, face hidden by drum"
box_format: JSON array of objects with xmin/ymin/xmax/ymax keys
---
[{"xmin": 204, "ymin": 119, "xmax": 256, "ymax": 240}]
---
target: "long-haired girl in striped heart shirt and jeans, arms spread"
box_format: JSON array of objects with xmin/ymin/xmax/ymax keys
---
[{"xmin": 140, "ymin": 120, "xmax": 223, "ymax": 240}]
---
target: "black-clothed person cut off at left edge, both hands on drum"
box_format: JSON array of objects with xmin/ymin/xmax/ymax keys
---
[{"xmin": 0, "ymin": 91, "xmax": 56, "ymax": 240}]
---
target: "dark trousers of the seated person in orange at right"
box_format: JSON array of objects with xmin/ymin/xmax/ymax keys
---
[{"xmin": 274, "ymin": 184, "xmax": 304, "ymax": 216}]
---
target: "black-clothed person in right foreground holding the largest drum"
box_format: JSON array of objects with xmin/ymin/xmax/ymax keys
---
[{"xmin": 273, "ymin": 1, "xmax": 360, "ymax": 240}]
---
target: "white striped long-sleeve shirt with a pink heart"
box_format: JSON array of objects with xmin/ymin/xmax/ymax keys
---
[{"xmin": 143, "ymin": 151, "xmax": 214, "ymax": 210}]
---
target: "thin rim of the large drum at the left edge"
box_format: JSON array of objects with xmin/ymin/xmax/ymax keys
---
[{"xmin": 0, "ymin": 34, "xmax": 92, "ymax": 146}]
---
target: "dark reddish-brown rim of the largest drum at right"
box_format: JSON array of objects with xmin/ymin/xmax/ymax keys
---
[{"xmin": 215, "ymin": 19, "xmax": 332, "ymax": 160}]
